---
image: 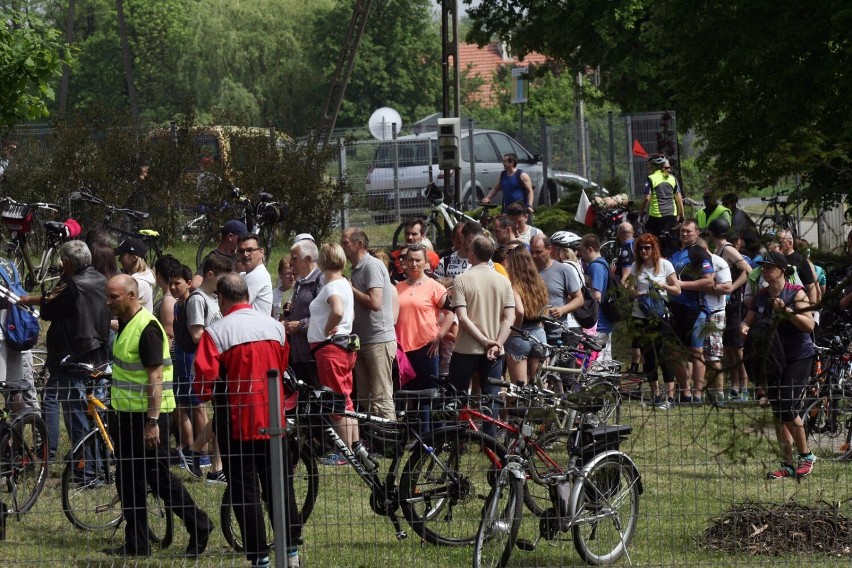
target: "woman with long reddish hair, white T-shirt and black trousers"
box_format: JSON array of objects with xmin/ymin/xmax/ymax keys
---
[{"xmin": 627, "ymin": 233, "xmax": 680, "ymax": 410}]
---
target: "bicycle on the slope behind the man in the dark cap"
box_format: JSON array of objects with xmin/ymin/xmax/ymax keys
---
[{"xmin": 190, "ymin": 187, "xmax": 287, "ymax": 267}]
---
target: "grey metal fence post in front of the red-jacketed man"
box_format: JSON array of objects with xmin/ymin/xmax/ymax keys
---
[{"xmin": 261, "ymin": 369, "xmax": 287, "ymax": 568}]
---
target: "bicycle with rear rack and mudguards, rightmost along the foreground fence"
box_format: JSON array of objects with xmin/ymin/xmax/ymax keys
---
[{"xmin": 473, "ymin": 379, "xmax": 643, "ymax": 568}]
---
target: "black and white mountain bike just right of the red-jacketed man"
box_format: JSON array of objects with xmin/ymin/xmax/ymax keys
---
[{"xmin": 221, "ymin": 370, "xmax": 505, "ymax": 546}]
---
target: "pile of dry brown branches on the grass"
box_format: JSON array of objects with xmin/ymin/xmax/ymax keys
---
[{"xmin": 701, "ymin": 501, "xmax": 852, "ymax": 556}]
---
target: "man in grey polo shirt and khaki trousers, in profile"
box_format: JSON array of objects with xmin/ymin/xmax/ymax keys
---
[{"xmin": 340, "ymin": 227, "xmax": 396, "ymax": 420}]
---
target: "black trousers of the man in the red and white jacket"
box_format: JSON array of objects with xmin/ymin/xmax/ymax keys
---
[{"xmin": 213, "ymin": 406, "xmax": 302, "ymax": 561}]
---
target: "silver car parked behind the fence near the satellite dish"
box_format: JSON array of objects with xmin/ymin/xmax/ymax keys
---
[{"xmin": 365, "ymin": 129, "xmax": 594, "ymax": 223}]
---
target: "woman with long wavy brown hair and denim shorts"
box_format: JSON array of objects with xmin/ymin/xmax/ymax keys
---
[{"xmin": 504, "ymin": 247, "xmax": 548, "ymax": 384}]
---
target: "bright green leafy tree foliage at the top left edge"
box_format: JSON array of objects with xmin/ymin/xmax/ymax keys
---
[{"xmin": 0, "ymin": 10, "xmax": 69, "ymax": 126}]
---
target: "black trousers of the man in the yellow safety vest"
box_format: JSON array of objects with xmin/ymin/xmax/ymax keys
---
[{"xmin": 109, "ymin": 412, "xmax": 213, "ymax": 554}]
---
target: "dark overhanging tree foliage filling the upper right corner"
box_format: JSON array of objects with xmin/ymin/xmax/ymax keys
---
[{"xmin": 469, "ymin": 0, "xmax": 852, "ymax": 211}]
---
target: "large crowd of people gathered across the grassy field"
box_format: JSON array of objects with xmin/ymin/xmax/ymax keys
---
[{"xmin": 0, "ymin": 150, "xmax": 852, "ymax": 566}]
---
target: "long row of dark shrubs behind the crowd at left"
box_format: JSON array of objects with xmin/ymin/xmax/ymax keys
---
[{"xmin": 4, "ymin": 110, "xmax": 348, "ymax": 242}]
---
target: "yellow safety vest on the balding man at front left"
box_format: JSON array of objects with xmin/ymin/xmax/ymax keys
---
[{"xmin": 110, "ymin": 309, "xmax": 175, "ymax": 412}]
